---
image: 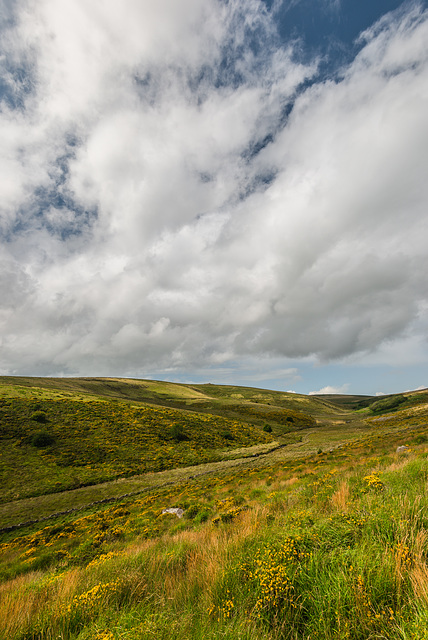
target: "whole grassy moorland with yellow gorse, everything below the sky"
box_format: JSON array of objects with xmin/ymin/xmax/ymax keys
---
[{"xmin": 0, "ymin": 378, "xmax": 428, "ymax": 640}]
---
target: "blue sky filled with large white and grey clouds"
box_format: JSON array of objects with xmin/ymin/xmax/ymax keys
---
[{"xmin": 0, "ymin": 0, "xmax": 428, "ymax": 395}]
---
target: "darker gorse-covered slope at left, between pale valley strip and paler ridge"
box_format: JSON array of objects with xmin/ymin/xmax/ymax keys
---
[{"xmin": 0, "ymin": 394, "xmax": 273, "ymax": 502}]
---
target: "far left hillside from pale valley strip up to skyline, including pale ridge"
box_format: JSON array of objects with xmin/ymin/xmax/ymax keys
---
[{"xmin": 0, "ymin": 377, "xmax": 324, "ymax": 502}]
